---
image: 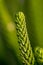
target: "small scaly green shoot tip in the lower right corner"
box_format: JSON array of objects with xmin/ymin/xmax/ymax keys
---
[{"xmin": 35, "ymin": 47, "xmax": 43, "ymax": 65}]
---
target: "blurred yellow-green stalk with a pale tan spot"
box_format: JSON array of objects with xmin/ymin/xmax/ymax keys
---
[{"xmin": 0, "ymin": 0, "xmax": 21, "ymax": 65}]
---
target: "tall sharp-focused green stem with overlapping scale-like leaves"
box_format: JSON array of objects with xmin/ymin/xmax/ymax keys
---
[{"xmin": 15, "ymin": 12, "xmax": 35, "ymax": 65}]
